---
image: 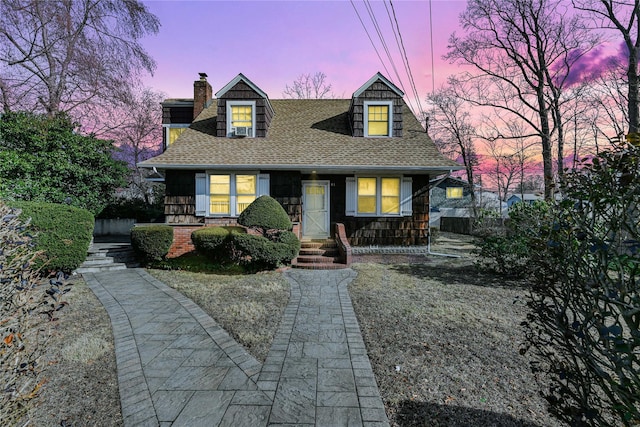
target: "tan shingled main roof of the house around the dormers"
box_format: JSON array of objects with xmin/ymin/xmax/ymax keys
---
[{"xmin": 139, "ymin": 99, "xmax": 461, "ymax": 174}]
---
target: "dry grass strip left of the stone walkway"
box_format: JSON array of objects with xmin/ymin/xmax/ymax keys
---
[{"xmin": 23, "ymin": 278, "xmax": 122, "ymax": 427}]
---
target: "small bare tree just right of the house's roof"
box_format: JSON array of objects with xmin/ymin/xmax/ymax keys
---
[{"xmin": 427, "ymin": 87, "xmax": 478, "ymax": 211}]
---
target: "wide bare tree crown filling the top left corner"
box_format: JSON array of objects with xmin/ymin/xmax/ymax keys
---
[{"xmin": 0, "ymin": 0, "xmax": 160, "ymax": 115}]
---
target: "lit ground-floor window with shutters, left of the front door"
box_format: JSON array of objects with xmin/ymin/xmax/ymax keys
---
[{"xmin": 196, "ymin": 172, "xmax": 269, "ymax": 217}]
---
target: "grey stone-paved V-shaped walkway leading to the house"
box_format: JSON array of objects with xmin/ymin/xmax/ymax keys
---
[{"xmin": 84, "ymin": 269, "xmax": 389, "ymax": 427}]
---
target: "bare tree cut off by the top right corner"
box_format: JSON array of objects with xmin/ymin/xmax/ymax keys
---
[{"xmin": 572, "ymin": 0, "xmax": 640, "ymax": 136}]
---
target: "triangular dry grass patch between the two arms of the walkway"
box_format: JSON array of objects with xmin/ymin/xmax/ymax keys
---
[{"xmin": 149, "ymin": 270, "xmax": 289, "ymax": 362}]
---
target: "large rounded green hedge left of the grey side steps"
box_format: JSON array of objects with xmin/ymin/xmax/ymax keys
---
[{"xmin": 10, "ymin": 201, "xmax": 94, "ymax": 273}]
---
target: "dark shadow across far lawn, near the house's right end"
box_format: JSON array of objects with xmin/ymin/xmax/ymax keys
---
[{"xmin": 390, "ymin": 262, "xmax": 526, "ymax": 289}]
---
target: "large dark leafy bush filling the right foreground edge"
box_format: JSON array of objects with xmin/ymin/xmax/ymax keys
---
[{"xmin": 524, "ymin": 145, "xmax": 640, "ymax": 426}]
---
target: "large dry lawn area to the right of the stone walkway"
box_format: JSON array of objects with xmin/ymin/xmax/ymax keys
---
[{"xmin": 349, "ymin": 250, "xmax": 559, "ymax": 427}]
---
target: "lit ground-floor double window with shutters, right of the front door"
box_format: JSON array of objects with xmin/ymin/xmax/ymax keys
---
[{"xmin": 346, "ymin": 176, "xmax": 412, "ymax": 216}]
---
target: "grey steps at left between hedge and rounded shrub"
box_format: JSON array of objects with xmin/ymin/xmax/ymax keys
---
[{"xmin": 76, "ymin": 242, "xmax": 138, "ymax": 274}]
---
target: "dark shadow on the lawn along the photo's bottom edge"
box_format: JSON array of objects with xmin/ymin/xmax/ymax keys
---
[{"xmin": 395, "ymin": 400, "xmax": 542, "ymax": 427}]
